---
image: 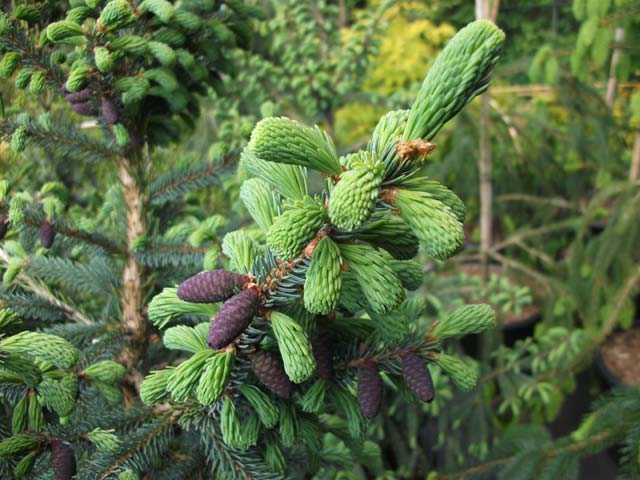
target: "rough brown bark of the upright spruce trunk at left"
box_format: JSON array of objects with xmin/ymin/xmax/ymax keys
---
[{"xmin": 120, "ymin": 157, "xmax": 148, "ymax": 370}]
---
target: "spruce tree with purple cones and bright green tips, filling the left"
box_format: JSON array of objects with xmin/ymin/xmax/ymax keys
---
[{"xmin": 0, "ymin": 7, "xmax": 504, "ymax": 480}]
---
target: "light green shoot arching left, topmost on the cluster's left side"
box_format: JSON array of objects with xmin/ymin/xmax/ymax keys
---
[{"xmin": 247, "ymin": 117, "xmax": 342, "ymax": 175}]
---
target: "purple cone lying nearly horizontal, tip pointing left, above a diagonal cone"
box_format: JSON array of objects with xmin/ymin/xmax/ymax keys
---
[{"xmin": 178, "ymin": 269, "xmax": 249, "ymax": 303}]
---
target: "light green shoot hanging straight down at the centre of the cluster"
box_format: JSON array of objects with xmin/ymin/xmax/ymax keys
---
[{"xmin": 304, "ymin": 236, "xmax": 342, "ymax": 315}]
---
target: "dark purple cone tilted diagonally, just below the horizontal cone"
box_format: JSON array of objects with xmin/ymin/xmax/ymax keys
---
[{"xmin": 207, "ymin": 288, "xmax": 258, "ymax": 350}]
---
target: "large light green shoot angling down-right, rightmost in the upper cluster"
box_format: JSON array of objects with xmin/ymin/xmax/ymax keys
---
[{"xmin": 394, "ymin": 189, "xmax": 464, "ymax": 260}]
